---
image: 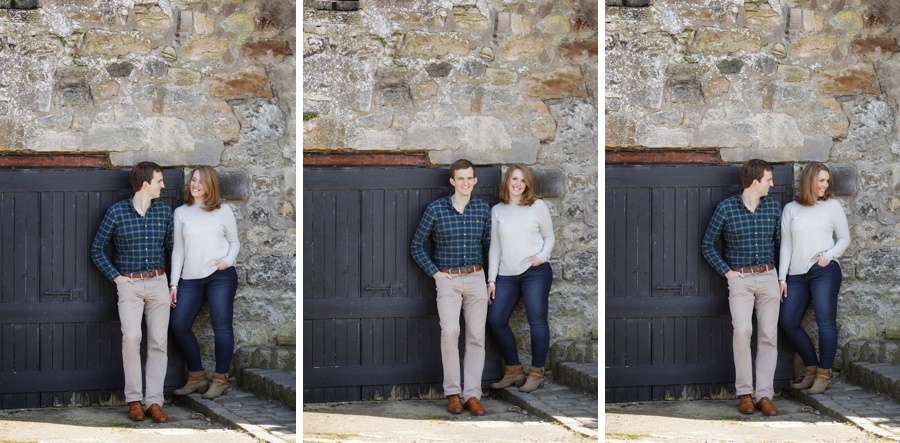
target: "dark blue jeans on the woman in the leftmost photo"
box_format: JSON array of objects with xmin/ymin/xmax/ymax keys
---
[{"xmin": 169, "ymin": 266, "xmax": 237, "ymax": 374}]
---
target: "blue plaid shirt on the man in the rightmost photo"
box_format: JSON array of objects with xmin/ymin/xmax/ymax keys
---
[{"xmin": 700, "ymin": 194, "xmax": 781, "ymax": 275}]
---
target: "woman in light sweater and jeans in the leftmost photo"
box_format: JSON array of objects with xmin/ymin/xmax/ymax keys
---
[{"xmin": 169, "ymin": 166, "xmax": 241, "ymax": 399}]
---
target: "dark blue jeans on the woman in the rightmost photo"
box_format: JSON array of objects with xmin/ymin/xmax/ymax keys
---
[{"xmin": 779, "ymin": 261, "xmax": 843, "ymax": 369}]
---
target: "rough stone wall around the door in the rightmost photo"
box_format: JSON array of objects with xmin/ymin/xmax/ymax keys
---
[{"xmin": 605, "ymin": 0, "xmax": 900, "ymax": 368}]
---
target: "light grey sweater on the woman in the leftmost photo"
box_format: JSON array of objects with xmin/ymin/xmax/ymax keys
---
[{"xmin": 169, "ymin": 204, "xmax": 241, "ymax": 284}]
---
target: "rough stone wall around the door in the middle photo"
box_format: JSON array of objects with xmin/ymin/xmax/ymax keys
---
[{"xmin": 303, "ymin": 0, "xmax": 598, "ymax": 363}]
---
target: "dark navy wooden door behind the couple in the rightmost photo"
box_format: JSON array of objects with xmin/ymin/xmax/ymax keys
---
[{"xmin": 605, "ymin": 165, "xmax": 793, "ymax": 402}]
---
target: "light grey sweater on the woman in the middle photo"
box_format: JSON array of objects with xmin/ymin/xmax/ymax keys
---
[{"xmin": 488, "ymin": 200, "xmax": 555, "ymax": 281}]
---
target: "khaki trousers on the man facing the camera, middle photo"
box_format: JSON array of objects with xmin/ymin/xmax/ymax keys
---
[{"xmin": 435, "ymin": 270, "xmax": 487, "ymax": 402}]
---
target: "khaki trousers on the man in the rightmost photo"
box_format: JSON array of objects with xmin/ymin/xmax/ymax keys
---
[{"xmin": 728, "ymin": 269, "xmax": 781, "ymax": 402}]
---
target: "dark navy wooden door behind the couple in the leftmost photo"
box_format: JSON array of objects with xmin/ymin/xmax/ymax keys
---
[{"xmin": 0, "ymin": 170, "xmax": 184, "ymax": 408}]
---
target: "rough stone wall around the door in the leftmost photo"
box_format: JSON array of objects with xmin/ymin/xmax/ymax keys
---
[{"xmin": 0, "ymin": 0, "xmax": 296, "ymax": 369}]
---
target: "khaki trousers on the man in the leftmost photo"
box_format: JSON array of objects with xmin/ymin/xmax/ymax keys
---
[{"xmin": 116, "ymin": 274, "xmax": 170, "ymax": 407}]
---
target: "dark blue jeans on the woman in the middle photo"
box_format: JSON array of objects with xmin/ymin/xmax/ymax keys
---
[{"xmin": 488, "ymin": 263, "xmax": 553, "ymax": 368}]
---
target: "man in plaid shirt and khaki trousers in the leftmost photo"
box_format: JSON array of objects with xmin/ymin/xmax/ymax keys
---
[{"xmin": 91, "ymin": 162, "xmax": 173, "ymax": 423}]
